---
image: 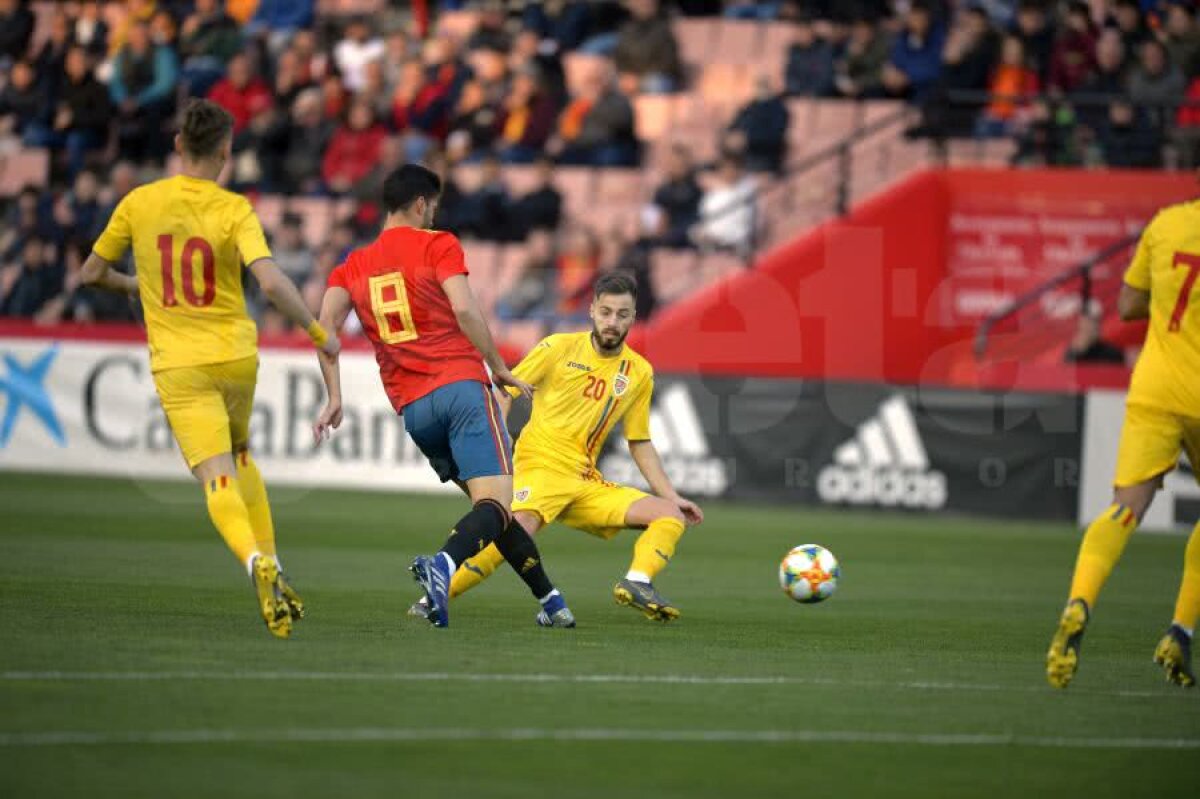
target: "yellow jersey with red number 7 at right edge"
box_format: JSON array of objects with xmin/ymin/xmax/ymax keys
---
[{"xmin": 1124, "ymin": 202, "xmax": 1200, "ymax": 419}]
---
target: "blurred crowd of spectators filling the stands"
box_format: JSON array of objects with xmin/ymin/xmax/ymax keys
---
[{"xmin": 0, "ymin": 0, "xmax": 1200, "ymax": 330}]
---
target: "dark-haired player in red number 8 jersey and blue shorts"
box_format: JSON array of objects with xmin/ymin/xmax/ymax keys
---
[{"xmin": 313, "ymin": 164, "xmax": 575, "ymax": 627}]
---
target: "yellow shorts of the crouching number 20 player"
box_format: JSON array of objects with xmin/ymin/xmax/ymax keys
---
[{"xmin": 512, "ymin": 464, "xmax": 649, "ymax": 540}]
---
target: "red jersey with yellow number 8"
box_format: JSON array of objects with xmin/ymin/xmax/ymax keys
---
[{"xmin": 329, "ymin": 227, "xmax": 488, "ymax": 411}]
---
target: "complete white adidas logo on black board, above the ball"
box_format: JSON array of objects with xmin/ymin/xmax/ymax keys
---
[{"xmin": 817, "ymin": 396, "xmax": 947, "ymax": 510}]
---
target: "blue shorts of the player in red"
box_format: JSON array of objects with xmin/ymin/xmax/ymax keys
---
[{"xmin": 402, "ymin": 380, "xmax": 512, "ymax": 482}]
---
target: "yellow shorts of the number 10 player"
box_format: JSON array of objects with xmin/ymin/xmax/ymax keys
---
[{"xmin": 154, "ymin": 355, "xmax": 258, "ymax": 469}]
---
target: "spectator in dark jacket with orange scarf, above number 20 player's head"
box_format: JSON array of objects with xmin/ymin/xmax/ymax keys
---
[{"xmin": 547, "ymin": 63, "xmax": 638, "ymax": 167}]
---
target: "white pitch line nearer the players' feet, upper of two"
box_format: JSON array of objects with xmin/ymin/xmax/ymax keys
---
[{"xmin": 0, "ymin": 671, "xmax": 1176, "ymax": 699}]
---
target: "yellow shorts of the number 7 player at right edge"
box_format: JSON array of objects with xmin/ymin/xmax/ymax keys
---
[{"xmin": 1114, "ymin": 404, "xmax": 1200, "ymax": 488}]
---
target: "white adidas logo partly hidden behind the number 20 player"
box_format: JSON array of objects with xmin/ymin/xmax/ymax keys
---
[{"xmin": 600, "ymin": 383, "xmax": 730, "ymax": 497}]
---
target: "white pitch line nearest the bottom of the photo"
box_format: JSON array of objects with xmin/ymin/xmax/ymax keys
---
[{"xmin": 0, "ymin": 727, "xmax": 1200, "ymax": 751}]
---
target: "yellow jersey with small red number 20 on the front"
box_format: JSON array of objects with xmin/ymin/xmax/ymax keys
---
[{"xmin": 509, "ymin": 331, "xmax": 654, "ymax": 476}]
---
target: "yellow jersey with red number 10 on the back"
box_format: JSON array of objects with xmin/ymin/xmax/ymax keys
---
[{"xmin": 92, "ymin": 175, "xmax": 271, "ymax": 372}]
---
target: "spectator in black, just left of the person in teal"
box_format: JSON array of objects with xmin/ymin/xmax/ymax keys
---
[{"xmin": 31, "ymin": 47, "xmax": 113, "ymax": 178}]
